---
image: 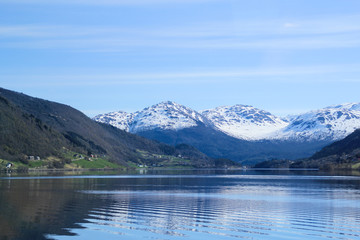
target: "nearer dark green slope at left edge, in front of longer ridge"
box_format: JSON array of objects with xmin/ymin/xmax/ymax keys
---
[{"xmin": 0, "ymin": 96, "xmax": 70, "ymax": 161}]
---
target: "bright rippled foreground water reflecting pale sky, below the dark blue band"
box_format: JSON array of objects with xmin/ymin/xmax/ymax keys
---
[{"xmin": 65, "ymin": 191, "xmax": 360, "ymax": 239}]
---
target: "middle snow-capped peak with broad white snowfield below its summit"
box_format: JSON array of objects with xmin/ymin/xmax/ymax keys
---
[{"xmin": 201, "ymin": 105, "xmax": 289, "ymax": 140}]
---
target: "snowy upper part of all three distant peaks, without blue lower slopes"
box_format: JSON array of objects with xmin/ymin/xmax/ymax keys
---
[{"xmin": 94, "ymin": 101, "xmax": 360, "ymax": 141}]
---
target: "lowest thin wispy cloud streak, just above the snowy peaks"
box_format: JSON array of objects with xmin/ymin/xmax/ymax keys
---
[{"xmin": 0, "ymin": 63, "xmax": 360, "ymax": 87}]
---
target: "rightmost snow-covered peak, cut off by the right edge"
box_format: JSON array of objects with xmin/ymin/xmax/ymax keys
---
[{"xmin": 269, "ymin": 103, "xmax": 360, "ymax": 141}]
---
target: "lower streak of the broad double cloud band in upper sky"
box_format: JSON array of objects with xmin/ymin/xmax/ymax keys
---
[{"xmin": 0, "ymin": 33, "xmax": 360, "ymax": 52}]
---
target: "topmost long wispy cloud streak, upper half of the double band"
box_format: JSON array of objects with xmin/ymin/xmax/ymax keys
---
[{"xmin": 0, "ymin": 14, "xmax": 360, "ymax": 38}]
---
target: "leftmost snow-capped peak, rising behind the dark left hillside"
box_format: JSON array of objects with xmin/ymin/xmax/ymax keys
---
[{"xmin": 94, "ymin": 101, "xmax": 211, "ymax": 133}]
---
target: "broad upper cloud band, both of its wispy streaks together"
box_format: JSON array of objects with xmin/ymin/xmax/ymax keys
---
[{"xmin": 0, "ymin": 14, "xmax": 360, "ymax": 52}]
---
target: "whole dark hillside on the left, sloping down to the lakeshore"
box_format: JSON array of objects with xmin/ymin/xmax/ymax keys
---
[{"xmin": 0, "ymin": 88, "xmax": 231, "ymax": 167}]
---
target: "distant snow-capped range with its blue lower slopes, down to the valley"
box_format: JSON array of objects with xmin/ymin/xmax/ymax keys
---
[{"xmin": 94, "ymin": 101, "xmax": 360, "ymax": 163}]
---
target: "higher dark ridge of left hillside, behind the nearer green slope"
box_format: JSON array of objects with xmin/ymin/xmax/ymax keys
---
[{"xmin": 0, "ymin": 88, "xmax": 214, "ymax": 166}]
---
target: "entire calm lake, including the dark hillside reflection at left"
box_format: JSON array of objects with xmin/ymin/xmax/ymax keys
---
[{"xmin": 0, "ymin": 171, "xmax": 360, "ymax": 240}]
